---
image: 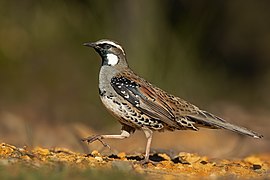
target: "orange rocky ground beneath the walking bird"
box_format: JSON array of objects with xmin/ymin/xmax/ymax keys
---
[{"xmin": 0, "ymin": 143, "xmax": 270, "ymax": 179}]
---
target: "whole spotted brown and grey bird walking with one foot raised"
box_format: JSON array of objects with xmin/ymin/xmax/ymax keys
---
[{"xmin": 82, "ymin": 39, "xmax": 263, "ymax": 163}]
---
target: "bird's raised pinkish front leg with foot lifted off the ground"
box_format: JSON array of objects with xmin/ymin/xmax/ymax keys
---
[{"xmin": 82, "ymin": 130, "xmax": 130, "ymax": 149}]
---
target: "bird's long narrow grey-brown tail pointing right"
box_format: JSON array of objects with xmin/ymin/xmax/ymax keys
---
[{"xmin": 189, "ymin": 111, "xmax": 263, "ymax": 138}]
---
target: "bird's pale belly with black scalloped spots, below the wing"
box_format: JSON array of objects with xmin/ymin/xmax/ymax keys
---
[{"xmin": 101, "ymin": 96, "xmax": 164, "ymax": 130}]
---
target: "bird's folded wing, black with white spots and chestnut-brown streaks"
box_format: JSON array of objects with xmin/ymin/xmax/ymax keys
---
[{"xmin": 111, "ymin": 75, "xmax": 179, "ymax": 127}]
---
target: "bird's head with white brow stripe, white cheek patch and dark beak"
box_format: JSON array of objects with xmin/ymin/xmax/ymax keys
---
[{"xmin": 83, "ymin": 39, "xmax": 128, "ymax": 66}]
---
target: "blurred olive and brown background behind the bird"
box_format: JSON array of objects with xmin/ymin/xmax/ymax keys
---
[{"xmin": 0, "ymin": 0, "xmax": 270, "ymax": 157}]
